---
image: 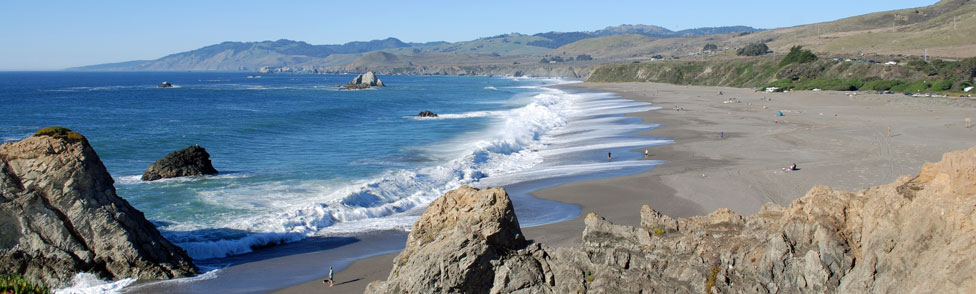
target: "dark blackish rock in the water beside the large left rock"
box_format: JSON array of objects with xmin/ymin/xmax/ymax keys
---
[{"xmin": 142, "ymin": 145, "xmax": 217, "ymax": 181}]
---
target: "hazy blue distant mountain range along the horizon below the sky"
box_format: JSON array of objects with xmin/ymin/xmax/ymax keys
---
[{"xmin": 70, "ymin": 25, "xmax": 759, "ymax": 71}]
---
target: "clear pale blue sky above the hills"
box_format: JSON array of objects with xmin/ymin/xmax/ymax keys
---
[{"xmin": 0, "ymin": 0, "xmax": 937, "ymax": 70}]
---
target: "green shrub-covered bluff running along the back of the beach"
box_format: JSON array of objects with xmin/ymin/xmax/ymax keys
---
[{"xmin": 588, "ymin": 50, "xmax": 976, "ymax": 93}]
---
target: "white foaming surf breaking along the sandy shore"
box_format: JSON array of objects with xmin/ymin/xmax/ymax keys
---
[{"xmin": 162, "ymin": 78, "xmax": 669, "ymax": 259}]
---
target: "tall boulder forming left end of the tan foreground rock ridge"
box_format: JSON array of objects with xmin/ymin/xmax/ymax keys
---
[{"xmin": 367, "ymin": 186, "xmax": 526, "ymax": 293}]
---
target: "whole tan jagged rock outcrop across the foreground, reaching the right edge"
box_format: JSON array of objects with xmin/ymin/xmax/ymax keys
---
[{"xmin": 366, "ymin": 148, "xmax": 976, "ymax": 293}]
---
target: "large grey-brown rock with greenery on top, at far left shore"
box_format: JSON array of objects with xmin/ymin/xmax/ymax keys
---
[{"xmin": 0, "ymin": 128, "xmax": 197, "ymax": 286}]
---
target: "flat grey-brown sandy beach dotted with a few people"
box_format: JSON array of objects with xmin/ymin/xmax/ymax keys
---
[{"xmin": 279, "ymin": 83, "xmax": 976, "ymax": 293}]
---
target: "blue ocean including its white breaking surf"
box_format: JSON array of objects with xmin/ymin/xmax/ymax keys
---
[{"xmin": 0, "ymin": 72, "xmax": 670, "ymax": 292}]
